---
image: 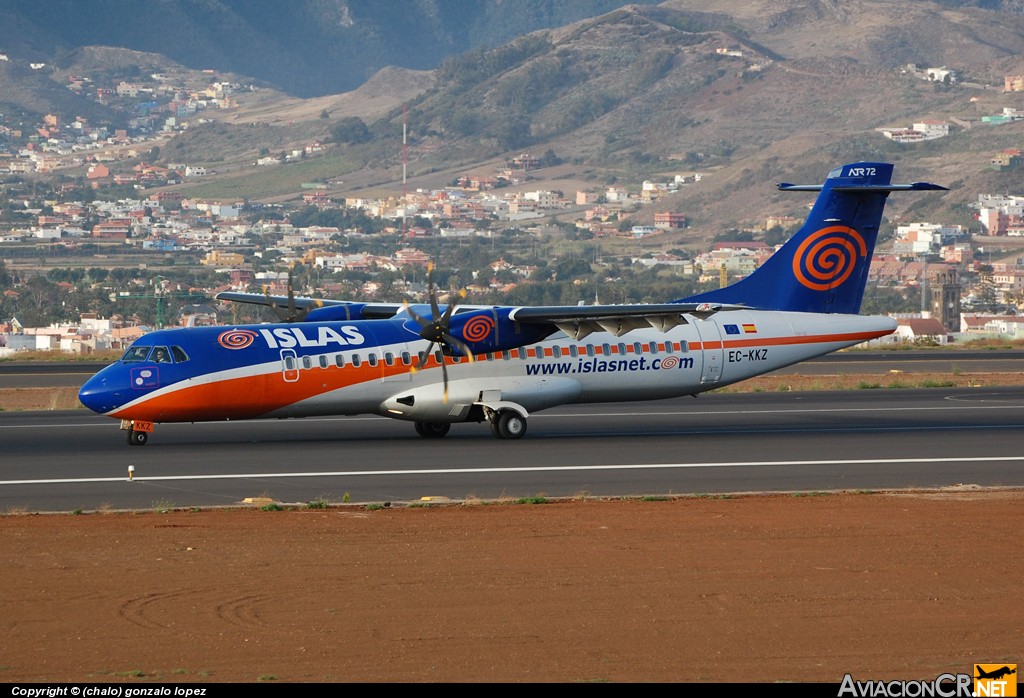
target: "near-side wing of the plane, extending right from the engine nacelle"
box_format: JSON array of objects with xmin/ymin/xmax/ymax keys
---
[{"xmin": 509, "ymin": 303, "xmax": 746, "ymax": 340}]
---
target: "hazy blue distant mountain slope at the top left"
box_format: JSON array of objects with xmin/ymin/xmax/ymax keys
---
[{"xmin": 0, "ymin": 0, "xmax": 651, "ymax": 97}]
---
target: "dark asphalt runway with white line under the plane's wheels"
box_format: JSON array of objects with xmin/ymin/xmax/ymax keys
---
[{"xmin": 0, "ymin": 388, "xmax": 1024, "ymax": 512}]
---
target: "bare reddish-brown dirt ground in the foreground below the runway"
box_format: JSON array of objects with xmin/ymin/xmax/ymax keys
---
[{"xmin": 0, "ymin": 488, "xmax": 1024, "ymax": 684}]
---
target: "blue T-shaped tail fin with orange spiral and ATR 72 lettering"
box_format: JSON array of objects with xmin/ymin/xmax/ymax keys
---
[{"xmin": 682, "ymin": 163, "xmax": 946, "ymax": 314}]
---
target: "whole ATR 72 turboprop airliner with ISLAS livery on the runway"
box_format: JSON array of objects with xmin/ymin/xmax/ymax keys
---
[{"xmin": 79, "ymin": 163, "xmax": 946, "ymax": 445}]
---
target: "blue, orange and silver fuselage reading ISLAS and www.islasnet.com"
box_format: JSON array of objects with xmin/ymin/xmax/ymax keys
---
[{"xmin": 80, "ymin": 310, "xmax": 896, "ymax": 423}]
